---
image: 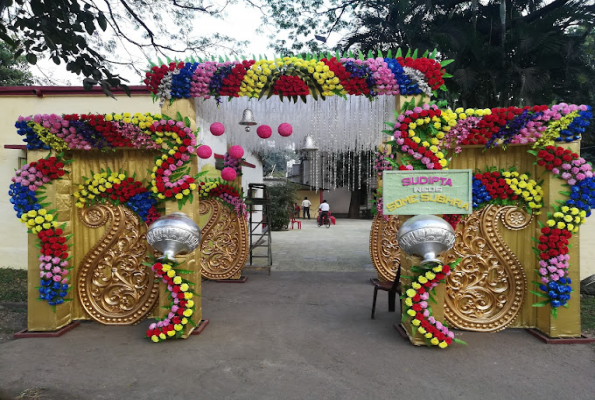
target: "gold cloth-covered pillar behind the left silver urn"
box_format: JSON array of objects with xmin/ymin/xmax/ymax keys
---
[{"xmin": 159, "ymin": 99, "xmax": 202, "ymax": 338}]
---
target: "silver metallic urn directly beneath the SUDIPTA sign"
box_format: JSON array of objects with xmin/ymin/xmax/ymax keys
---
[{"xmin": 397, "ymin": 215, "xmax": 455, "ymax": 265}]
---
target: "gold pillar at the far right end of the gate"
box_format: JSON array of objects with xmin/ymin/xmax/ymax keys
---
[{"xmin": 532, "ymin": 141, "xmax": 581, "ymax": 338}]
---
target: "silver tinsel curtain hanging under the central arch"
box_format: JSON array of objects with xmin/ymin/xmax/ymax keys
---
[{"xmin": 195, "ymin": 96, "xmax": 396, "ymax": 189}]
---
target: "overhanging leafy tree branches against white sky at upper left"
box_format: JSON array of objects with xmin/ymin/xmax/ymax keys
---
[{"xmin": 0, "ymin": 0, "xmax": 246, "ymax": 96}]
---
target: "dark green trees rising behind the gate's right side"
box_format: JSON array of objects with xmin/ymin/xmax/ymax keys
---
[{"xmin": 264, "ymin": 0, "xmax": 595, "ymax": 107}]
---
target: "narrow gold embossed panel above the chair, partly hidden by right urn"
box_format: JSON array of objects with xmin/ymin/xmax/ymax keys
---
[{"xmin": 370, "ymin": 215, "xmax": 401, "ymax": 281}]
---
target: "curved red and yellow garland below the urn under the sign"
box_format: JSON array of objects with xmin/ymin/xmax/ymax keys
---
[{"xmin": 401, "ymin": 260, "xmax": 466, "ymax": 349}]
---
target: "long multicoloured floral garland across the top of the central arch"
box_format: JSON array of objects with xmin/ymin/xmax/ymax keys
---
[{"xmin": 144, "ymin": 50, "xmax": 451, "ymax": 102}]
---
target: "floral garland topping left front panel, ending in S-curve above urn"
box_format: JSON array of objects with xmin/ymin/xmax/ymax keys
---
[{"xmin": 17, "ymin": 113, "xmax": 197, "ymax": 207}]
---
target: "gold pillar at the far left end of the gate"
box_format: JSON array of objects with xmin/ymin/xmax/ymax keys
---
[{"xmin": 22, "ymin": 150, "xmax": 76, "ymax": 332}]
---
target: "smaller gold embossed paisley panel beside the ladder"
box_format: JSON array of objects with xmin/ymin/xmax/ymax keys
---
[{"xmin": 199, "ymin": 199, "xmax": 249, "ymax": 280}]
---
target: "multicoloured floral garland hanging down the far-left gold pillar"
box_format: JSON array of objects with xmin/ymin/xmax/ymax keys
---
[{"xmin": 8, "ymin": 154, "xmax": 72, "ymax": 306}]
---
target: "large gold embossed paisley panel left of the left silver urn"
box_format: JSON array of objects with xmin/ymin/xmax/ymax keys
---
[{"xmin": 77, "ymin": 204, "xmax": 158, "ymax": 325}]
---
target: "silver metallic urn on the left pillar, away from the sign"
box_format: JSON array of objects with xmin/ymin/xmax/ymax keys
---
[{"xmin": 147, "ymin": 212, "xmax": 200, "ymax": 260}]
